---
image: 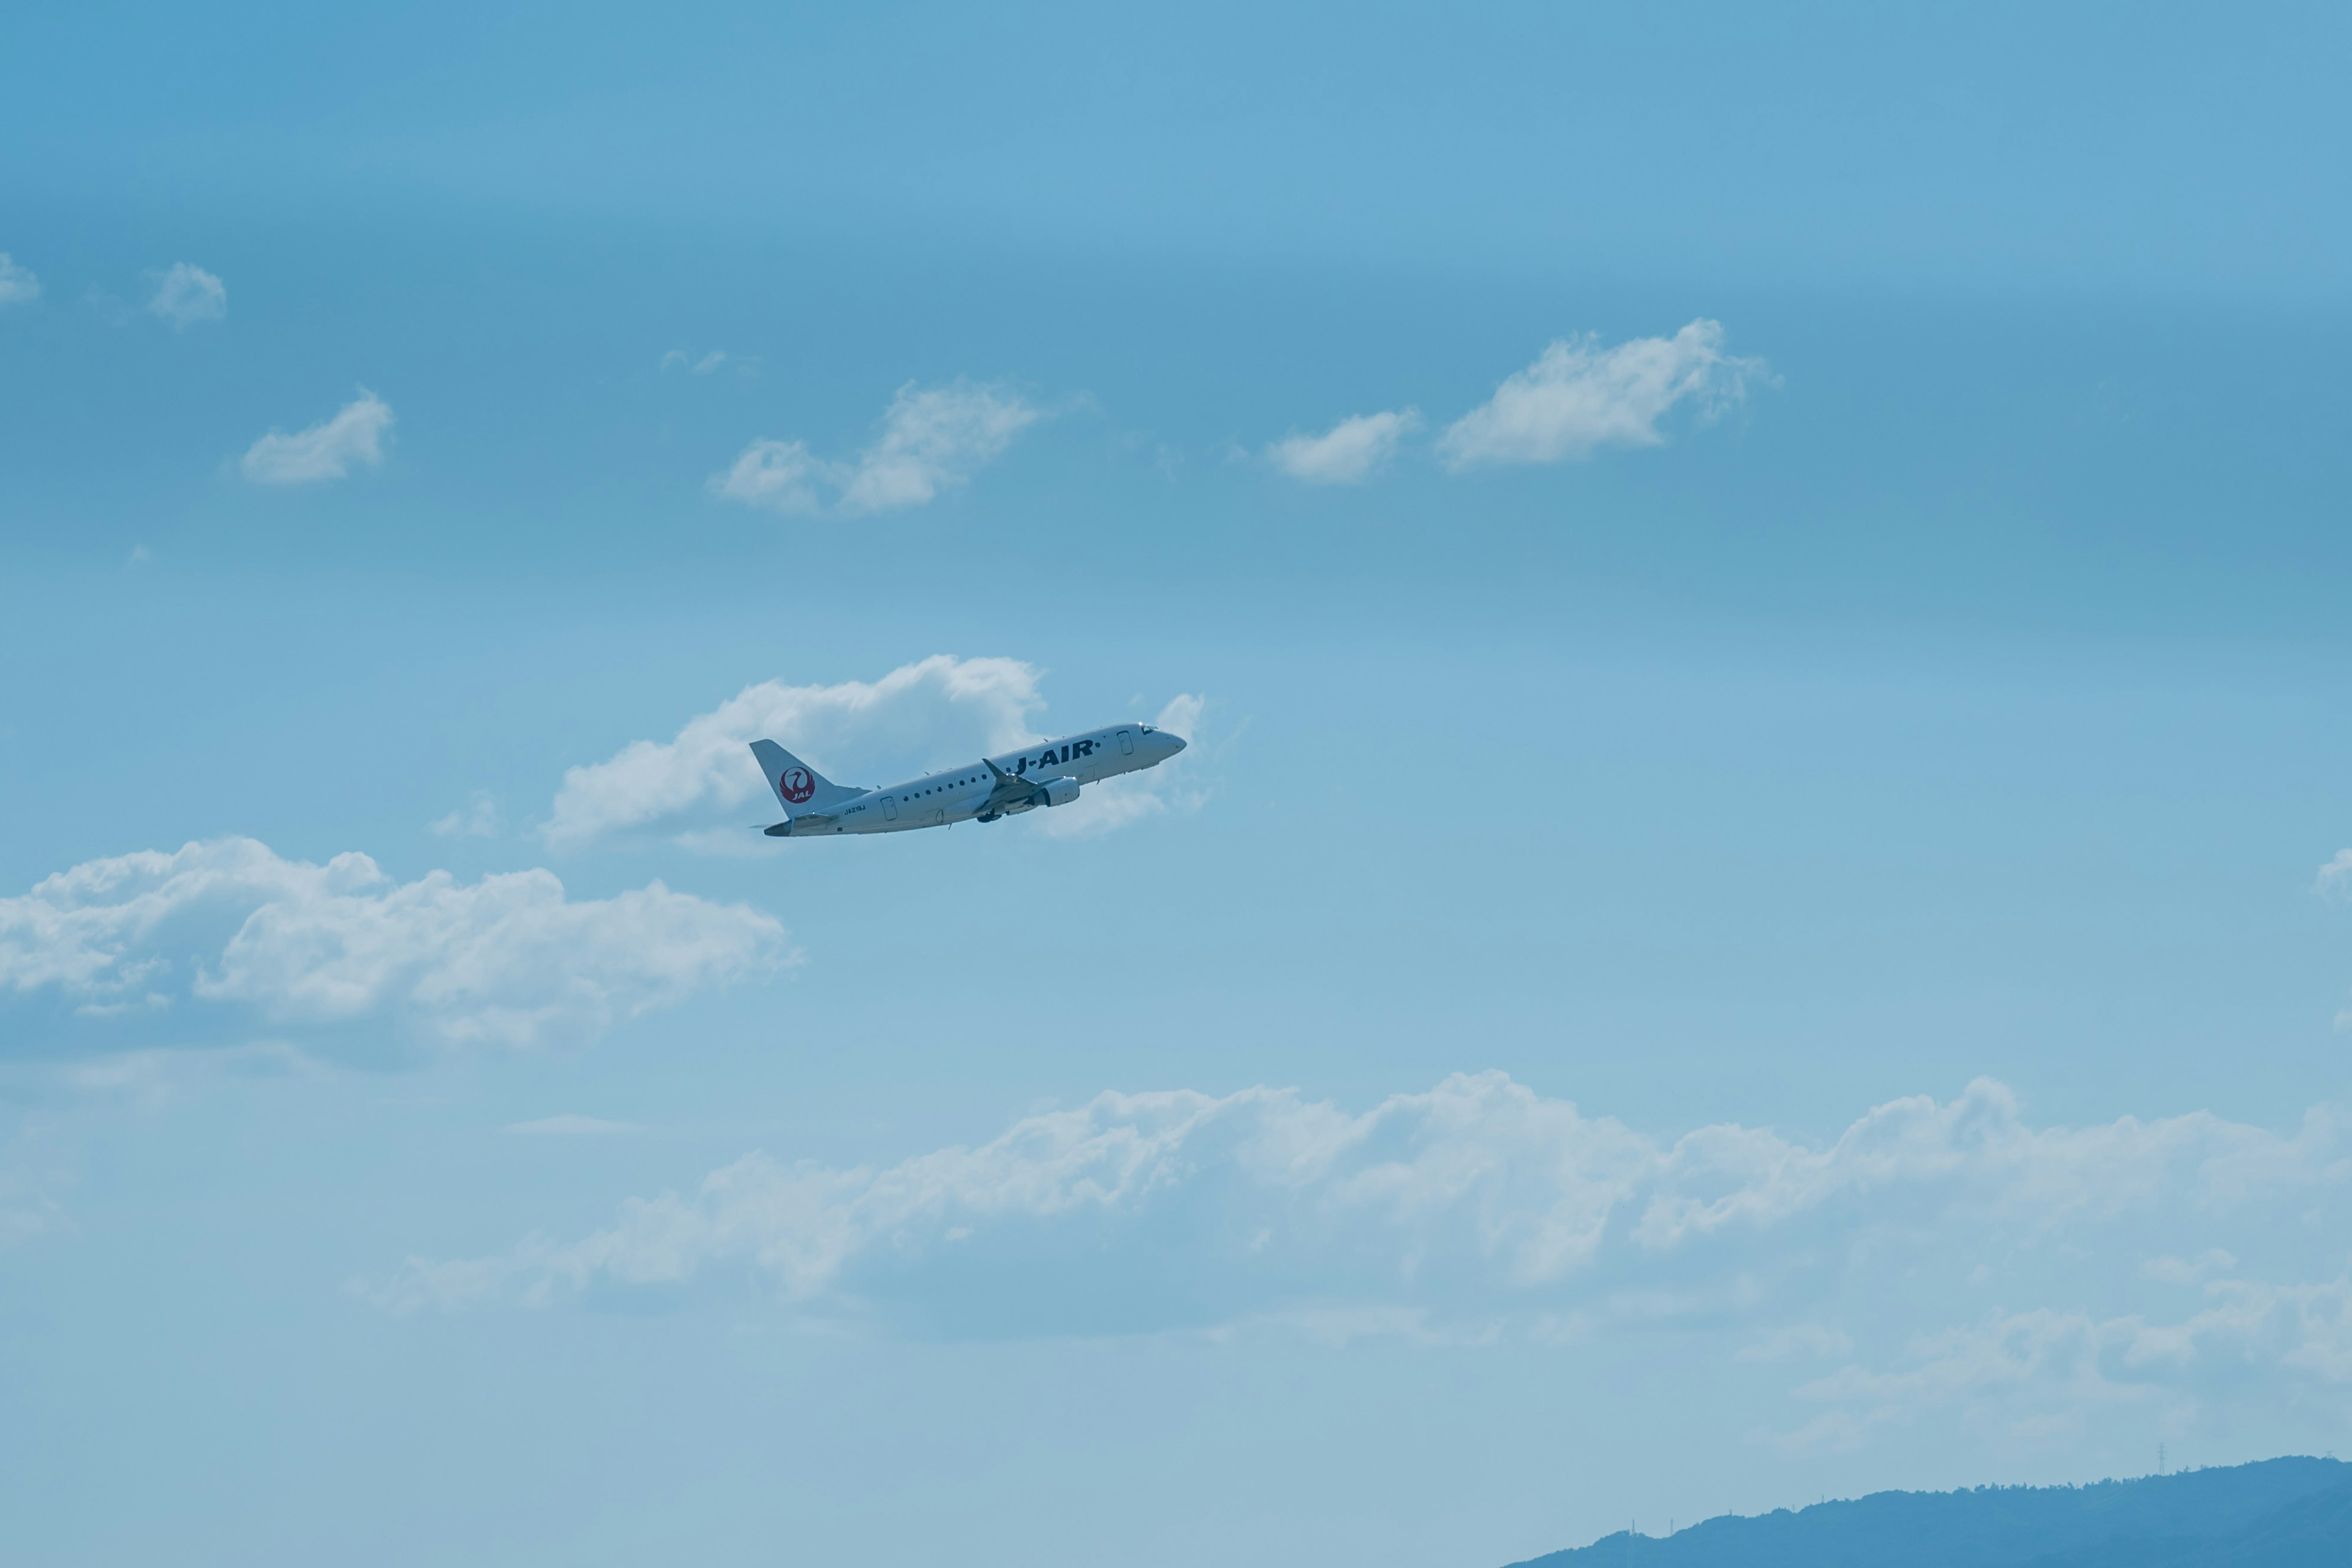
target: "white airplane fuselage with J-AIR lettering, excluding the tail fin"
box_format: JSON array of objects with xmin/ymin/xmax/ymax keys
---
[{"xmin": 790, "ymin": 724, "xmax": 1185, "ymax": 839}]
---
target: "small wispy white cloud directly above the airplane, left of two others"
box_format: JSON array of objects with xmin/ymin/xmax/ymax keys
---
[{"xmin": 694, "ymin": 380, "xmax": 1039, "ymax": 515}]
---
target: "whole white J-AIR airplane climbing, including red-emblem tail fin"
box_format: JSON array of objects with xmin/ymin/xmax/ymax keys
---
[{"xmin": 750, "ymin": 724, "xmax": 1183, "ymax": 839}]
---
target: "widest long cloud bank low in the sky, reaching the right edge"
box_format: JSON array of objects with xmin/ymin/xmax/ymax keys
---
[{"xmin": 364, "ymin": 1072, "xmax": 2352, "ymax": 1453}]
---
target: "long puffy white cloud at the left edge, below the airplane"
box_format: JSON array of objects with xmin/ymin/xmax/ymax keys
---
[{"xmin": 0, "ymin": 839, "xmax": 793, "ymax": 1046}]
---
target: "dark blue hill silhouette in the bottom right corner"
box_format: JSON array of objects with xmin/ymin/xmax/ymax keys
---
[{"xmin": 1512, "ymin": 1458, "xmax": 2352, "ymax": 1568}]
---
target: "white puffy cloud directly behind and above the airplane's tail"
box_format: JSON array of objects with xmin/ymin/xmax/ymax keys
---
[{"xmin": 541, "ymin": 654, "xmax": 1044, "ymax": 846}]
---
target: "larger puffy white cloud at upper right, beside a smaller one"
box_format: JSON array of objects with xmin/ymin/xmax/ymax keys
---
[{"xmin": 1437, "ymin": 320, "xmax": 1764, "ymax": 468}]
